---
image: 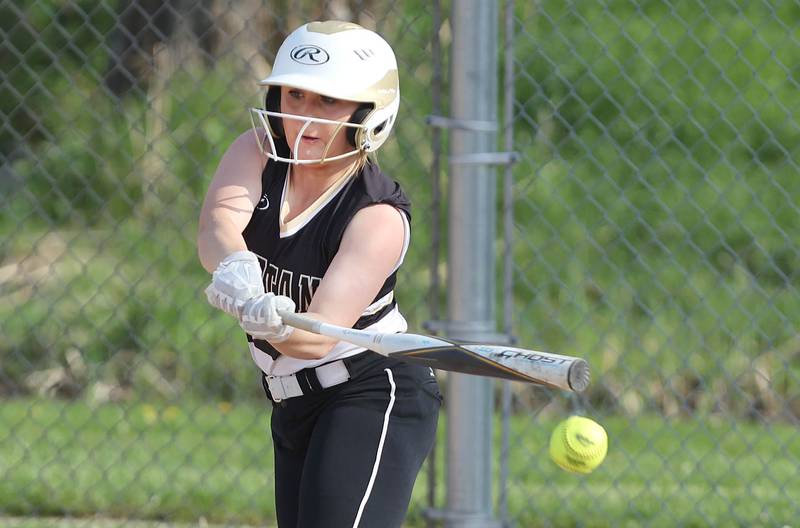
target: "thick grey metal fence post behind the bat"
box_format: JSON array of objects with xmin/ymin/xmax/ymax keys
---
[{"xmin": 444, "ymin": 0, "xmax": 499, "ymax": 528}]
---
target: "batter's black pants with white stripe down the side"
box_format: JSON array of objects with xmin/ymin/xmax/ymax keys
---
[{"xmin": 267, "ymin": 351, "xmax": 442, "ymax": 528}]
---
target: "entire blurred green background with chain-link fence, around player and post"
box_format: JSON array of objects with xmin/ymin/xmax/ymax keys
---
[{"xmin": 0, "ymin": 0, "xmax": 800, "ymax": 527}]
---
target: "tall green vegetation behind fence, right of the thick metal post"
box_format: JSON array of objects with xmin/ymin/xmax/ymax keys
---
[{"xmin": 514, "ymin": 2, "xmax": 800, "ymax": 414}]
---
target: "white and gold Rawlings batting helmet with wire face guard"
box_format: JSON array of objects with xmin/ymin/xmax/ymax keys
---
[{"xmin": 250, "ymin": 20, "xmax": 400, "ymax": 164}]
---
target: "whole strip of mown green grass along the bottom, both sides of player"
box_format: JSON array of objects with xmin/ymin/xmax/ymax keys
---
[{"xmin": 0, "ymin": 399, "xmax": 800, "ymax": 527}]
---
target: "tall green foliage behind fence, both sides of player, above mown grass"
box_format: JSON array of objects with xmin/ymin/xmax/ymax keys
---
[{"xmin": 0, "ymin": 1, "xmax": 800, "ymax": 416}]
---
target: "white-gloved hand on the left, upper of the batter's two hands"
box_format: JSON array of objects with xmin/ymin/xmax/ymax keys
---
[{"xmin": 206, "ymin": 251, "xmax": 264, "ymax": 317}]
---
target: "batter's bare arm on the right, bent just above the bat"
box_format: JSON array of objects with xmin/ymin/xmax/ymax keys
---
[{"xmin": 273, "ymin": 204, "xmax": 406, "ymax": 359}]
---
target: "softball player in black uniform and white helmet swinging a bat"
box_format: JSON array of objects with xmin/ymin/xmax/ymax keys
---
[{"xmin": 198, "ymin": 21, "xmax": 441, "ymax": 528}]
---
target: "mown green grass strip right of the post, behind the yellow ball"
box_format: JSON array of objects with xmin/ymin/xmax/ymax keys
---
[{"xmin": 496, "ymin": 417, "xmax": 800, "ymax": 526}]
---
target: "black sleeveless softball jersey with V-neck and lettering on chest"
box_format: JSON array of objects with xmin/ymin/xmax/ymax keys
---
[{"xmin": 242, "ymin": 151, "xmax": 411, "ymax": 359}]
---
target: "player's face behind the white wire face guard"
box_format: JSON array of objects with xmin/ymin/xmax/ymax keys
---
[{"xmin": 281, "ymin": 86, "xmax": 358, "ymax": 160}]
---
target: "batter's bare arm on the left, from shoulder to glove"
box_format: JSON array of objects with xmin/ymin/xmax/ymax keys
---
[{"xmin": 197, "ymin": 131, "xmax": 267, "ymax": 273}]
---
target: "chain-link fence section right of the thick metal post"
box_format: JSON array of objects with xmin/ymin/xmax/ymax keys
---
[{"xmin": 503, "ymin": 1, "xmax": 800, "ymax": 526}]
